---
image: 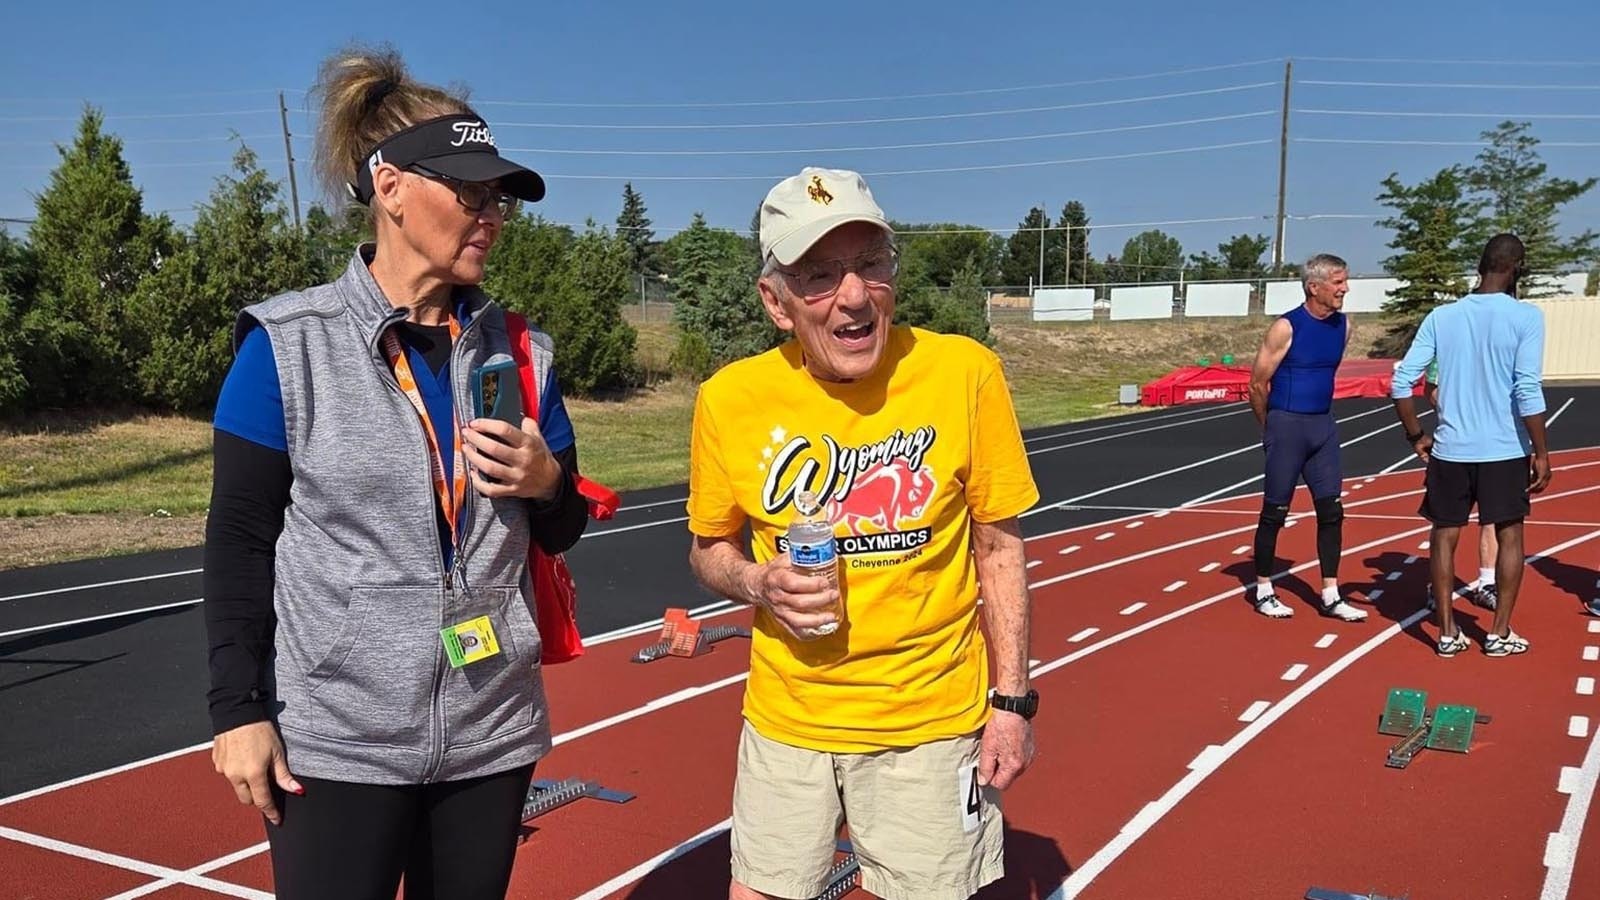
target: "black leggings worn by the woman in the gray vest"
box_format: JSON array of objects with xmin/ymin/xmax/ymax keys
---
[{"xmin": 267, "ymin": 765, "xmax": 533, "ymax": 900}]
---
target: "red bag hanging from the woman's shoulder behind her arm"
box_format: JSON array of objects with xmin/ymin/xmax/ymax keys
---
[{"xmin": 506, "ymin": 312, "xmax": 622, "ymax": 666}]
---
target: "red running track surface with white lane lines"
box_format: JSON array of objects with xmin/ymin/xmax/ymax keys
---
[{"xmin": 0, "ymin": 450, "xmax": 1600, "ymax": 900}]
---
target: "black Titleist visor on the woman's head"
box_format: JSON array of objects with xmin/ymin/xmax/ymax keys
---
[{"xmin": 350, "ymin": 115, "xmax": 544, "ymax": 203}]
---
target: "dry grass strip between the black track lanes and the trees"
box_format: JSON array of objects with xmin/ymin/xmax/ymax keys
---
[{"xmin": 0, "ymin": 317, "xmax": 1381, "ymax": 569}]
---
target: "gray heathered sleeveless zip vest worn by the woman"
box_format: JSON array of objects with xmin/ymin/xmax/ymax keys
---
[{"xmin": 235, "ymin": 248, "xmax": 550, "ymax": 785}]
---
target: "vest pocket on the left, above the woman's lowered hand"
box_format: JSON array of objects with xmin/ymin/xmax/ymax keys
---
[{"xmin": 299, "ymin": 588, "xmax": 443, "ymax": 751}]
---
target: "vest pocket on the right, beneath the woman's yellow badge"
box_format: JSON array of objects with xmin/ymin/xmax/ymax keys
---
[{"xmin": 442, "ymin": 586, "xmax": 544, "ymax": 748}]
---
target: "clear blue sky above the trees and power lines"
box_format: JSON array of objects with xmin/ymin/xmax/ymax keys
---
[{"xmin": 0, "ymin": 0, "xmax": 1600, "ymax": 271}]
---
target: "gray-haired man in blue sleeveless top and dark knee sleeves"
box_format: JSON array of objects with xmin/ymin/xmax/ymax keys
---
[{"xmin": 1250, "ymin": 253, "xmax": 1366, "ymax": 621}]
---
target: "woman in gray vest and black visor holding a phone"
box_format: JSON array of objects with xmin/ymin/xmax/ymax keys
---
[{"xmin": 205, "ymin": 43, "xmax": 587, "ymax": 900}]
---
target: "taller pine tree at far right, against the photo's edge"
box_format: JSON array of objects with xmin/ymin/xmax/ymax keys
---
[{"xmin": 1464, "ymin": 122, "xmax": 1600, "ymax": 296}]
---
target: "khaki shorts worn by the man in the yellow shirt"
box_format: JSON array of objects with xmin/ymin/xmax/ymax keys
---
[{"xmin": 731, "ymin": 722, "xmax": 1005, "ymax": 900}]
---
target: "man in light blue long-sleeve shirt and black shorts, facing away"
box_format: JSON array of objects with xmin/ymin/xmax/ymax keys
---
[{"xmin": 1390, "ymin": 234, "xmax": 1550, "ymax": 657}]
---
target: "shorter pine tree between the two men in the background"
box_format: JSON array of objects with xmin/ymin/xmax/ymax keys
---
[{"xmin": 1378, "ymin": 167, "xmax": 1482, "ymax": 356}]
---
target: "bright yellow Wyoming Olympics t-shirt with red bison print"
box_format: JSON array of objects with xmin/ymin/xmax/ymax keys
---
[{"xmin": 688, "ymin": 327, "xmax": 1038, "ymax": 753}]
